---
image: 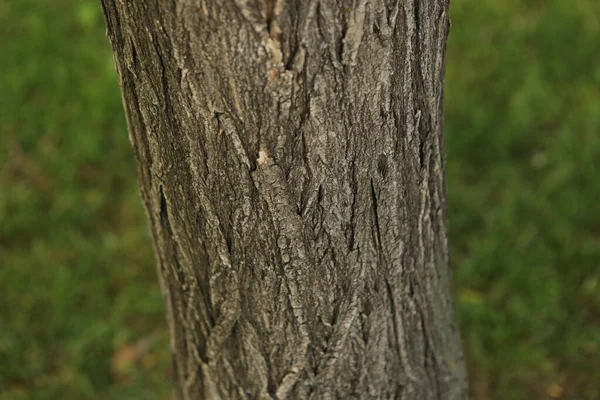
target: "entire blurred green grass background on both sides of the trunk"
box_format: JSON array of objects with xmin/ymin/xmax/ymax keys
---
[{"xmin": 0, "ymin": 0, "xmax": 600, "ymax": 400}]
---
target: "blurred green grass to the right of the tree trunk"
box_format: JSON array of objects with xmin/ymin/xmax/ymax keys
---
[{"xmin": 446, "ymin": 0, "xmax": 600, "ymax": 399}]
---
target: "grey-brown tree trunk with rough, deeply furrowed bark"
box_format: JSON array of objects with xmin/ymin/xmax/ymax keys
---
[{"xmin": 102, "ymin": 0, "xmax": 466, "ymax": 400}]
